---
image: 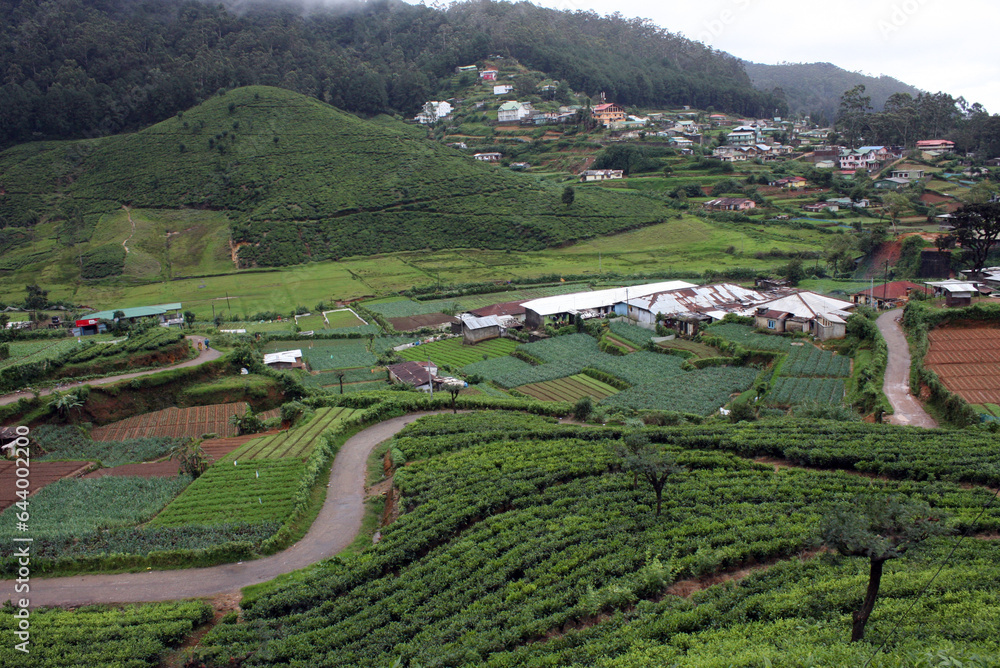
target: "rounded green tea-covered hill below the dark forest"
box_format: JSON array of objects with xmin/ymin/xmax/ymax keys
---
[{"xmin": 0, "ymin": 87, "xmax": 665, "ymax": 278}]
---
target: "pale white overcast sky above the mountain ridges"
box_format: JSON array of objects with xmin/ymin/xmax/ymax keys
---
[{"xmin": 504, "ymin": 0, "xmax": 1000, "ymax": 113}]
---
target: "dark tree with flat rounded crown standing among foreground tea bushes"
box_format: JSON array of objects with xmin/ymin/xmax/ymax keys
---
[{"xmin": 823, "ymin": 495, "xmax": 948, "ymax": 642}]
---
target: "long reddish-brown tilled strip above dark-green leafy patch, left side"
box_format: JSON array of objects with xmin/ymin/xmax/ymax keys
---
[{"xmin": 91, "ymin": 401, "xmax": 278, "ymax": 441}]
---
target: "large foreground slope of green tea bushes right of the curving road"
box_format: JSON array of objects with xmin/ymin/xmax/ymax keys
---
[{"xmin": 197, "ymin": 413, "xmax": 1000, "ymax": 668}]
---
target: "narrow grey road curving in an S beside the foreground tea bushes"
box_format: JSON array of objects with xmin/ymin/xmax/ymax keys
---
[{"xmin": 0, "ymin": 411, "xmax": 438, "ymax": 607}]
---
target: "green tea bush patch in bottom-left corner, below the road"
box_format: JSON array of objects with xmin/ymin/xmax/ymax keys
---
[{"xmin": 0, "ymin": 601, "xmax": 212, "ymax": 668}]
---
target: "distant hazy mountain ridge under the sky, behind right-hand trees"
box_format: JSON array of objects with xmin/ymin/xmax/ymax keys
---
[{"xmin": 743, "ymin": 61, "xmax": 920, "ymax": 125}]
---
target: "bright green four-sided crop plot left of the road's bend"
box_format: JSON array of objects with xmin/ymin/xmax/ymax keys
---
[{"xmin": 150, "ymin": 458, "xmax": 305, "ymax": 526}]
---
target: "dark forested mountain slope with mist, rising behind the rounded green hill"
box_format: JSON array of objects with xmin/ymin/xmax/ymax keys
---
[{"xmin": 0, "ymin": 0, "xmax": 785, "ymax": 146}]
